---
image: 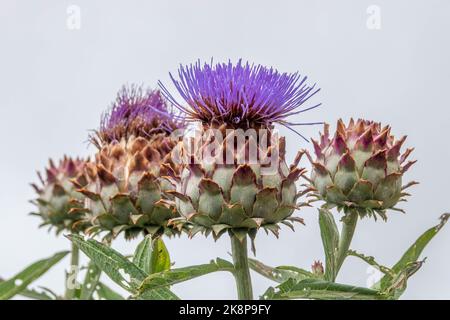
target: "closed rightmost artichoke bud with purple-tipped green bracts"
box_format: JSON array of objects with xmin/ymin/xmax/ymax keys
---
[{"xmin": 308, "ymin": 119, "xmax": 417, "ymax": 220}]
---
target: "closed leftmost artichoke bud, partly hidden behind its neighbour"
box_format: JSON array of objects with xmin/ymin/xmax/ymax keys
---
[{"xmin": 31, "ymin": 156, "xmax": 86, "ymax": 234}]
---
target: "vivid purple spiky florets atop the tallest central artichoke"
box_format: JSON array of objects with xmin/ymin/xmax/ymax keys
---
[{"xmin": 159, "ymin": 60, "xmax": 320, "ymax": 128}]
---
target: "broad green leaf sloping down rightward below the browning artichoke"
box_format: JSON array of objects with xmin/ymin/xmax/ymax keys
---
[{"xmin": 67, "ymin": 235, "xmax": 178, "ymax": 299}]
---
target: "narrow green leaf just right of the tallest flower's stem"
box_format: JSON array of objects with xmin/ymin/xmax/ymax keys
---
[{"xmin": 248, "ymin": 259, "xmax": 319, "ymax": 283}]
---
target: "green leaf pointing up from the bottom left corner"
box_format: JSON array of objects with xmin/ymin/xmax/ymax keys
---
[{"xmin": 0, "ymin": 251, "xmax": 68, "ymax": 300}]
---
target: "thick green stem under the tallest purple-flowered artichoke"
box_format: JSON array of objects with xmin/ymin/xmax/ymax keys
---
[{"xmin": 231, "ymin": 235, "xmax": 253, "ymax": 300}]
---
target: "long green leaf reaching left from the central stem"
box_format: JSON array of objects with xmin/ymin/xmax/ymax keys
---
[{"xmin": 138, "ymin": 258, "xmax": 234, "ymax": 297}]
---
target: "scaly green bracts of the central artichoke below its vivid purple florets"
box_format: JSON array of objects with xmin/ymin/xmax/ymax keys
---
[{"xmin": 167, "ymin": 128, "xmax": 305, "ymax": 238}]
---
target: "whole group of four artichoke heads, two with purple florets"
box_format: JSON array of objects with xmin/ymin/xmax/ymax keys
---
[{"xmin": 33, "ymin": 61, "xmax": 415, "ymax": 245}]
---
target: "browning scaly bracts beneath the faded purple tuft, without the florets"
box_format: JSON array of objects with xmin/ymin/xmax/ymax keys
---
[{"xmin": 75, "ymin": 134, "xmax": 183, "ymax": 239}]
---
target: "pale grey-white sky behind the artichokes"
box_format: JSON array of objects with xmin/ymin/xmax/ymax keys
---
[{"xmin": 0, "ymin": 0, "xmax": 450, "ymax": 299}]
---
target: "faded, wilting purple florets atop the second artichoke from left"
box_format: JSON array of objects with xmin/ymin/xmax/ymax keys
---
[{"xmin": 91, "ymin": 84, "xmax": 185, "ymax": 146}]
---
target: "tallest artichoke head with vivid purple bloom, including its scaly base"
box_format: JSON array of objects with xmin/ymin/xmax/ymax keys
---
[{"xmin": 160, "ymin": 61, "xmax": 318, "ymax": 239}]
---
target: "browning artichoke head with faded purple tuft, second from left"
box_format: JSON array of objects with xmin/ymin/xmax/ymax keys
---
[{"xmin": 75, "ymin": 86, "xmax": 183, "ymax": 239}]
